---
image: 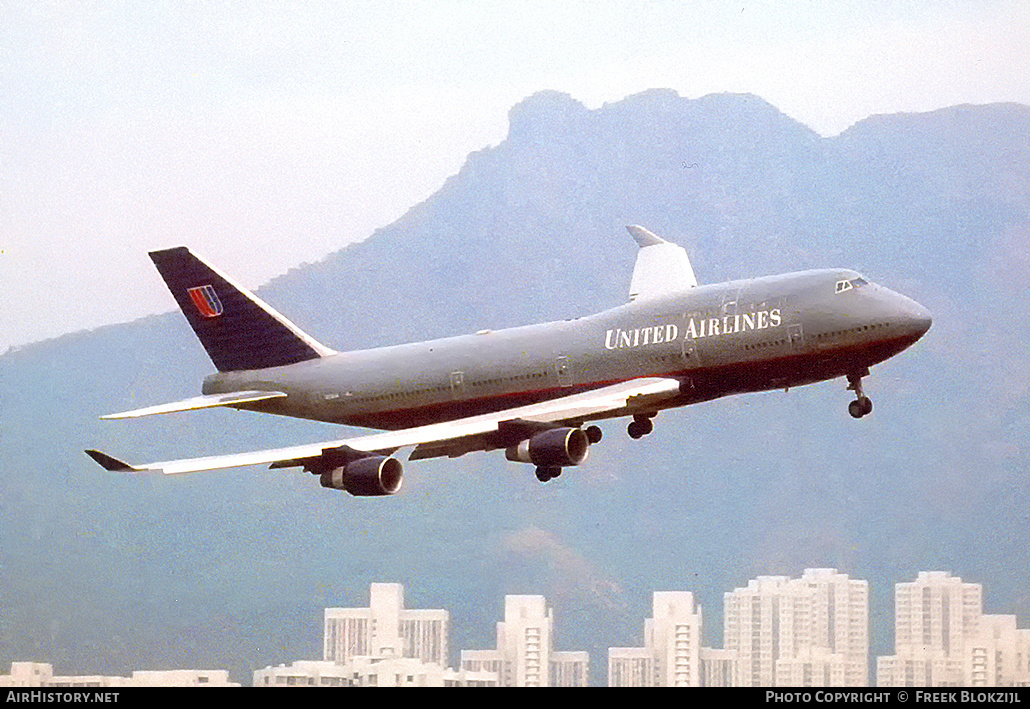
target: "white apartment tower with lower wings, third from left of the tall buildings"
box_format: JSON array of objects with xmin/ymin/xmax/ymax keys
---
[{"xmin": 608, "ymin": 592, "xmax": 701, "ymax": 686}]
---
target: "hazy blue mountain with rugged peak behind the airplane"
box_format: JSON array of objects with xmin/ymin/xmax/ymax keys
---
[{"xmin": 0, "ymin": 90, "xmax": 1030, "ymax": 683}]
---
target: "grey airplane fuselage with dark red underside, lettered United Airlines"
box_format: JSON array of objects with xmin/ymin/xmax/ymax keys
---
[{"xmin": 203, "ymin": 269, "xmax": 930, "ymax": 430}]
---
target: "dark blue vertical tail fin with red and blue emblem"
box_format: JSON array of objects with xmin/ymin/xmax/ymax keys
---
[{"xmin": 150, "ymin": 246, "xmax": 333, "ymax": 372}]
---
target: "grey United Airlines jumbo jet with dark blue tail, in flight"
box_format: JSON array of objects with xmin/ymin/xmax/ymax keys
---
[{"xmin": 87, "ymin": 226, "xmax": 931, "ymax": 496}]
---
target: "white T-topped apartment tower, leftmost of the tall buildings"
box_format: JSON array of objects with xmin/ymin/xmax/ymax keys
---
[{"xmin": 322, "ymin": 583, "xmax": 450, "ymax": 667}]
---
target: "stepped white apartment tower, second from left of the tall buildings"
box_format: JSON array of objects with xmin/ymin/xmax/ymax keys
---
[{"xmin": 461, "ymin": 596, "xmax": 589, "ymax": 686}]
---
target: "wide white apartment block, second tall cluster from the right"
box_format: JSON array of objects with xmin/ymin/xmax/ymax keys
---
[{"xmin": 723, "ymin": 569, "xmax": 869, "ymax": 686}]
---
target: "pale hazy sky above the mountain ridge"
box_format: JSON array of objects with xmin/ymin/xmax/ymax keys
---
[{"xmin": 0, "ymin": 0, "xmax": 1030, "ymax": 352}]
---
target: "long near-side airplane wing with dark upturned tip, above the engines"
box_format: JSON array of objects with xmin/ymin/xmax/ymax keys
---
[{"xmin": 85, "ymin": 377, "xmax": 680, "ymax": 475}]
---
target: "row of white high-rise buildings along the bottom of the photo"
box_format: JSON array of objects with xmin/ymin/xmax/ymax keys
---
[{"xmin": 6, "ymin": 568, "xmax": 1030, "ymax": 687}]
